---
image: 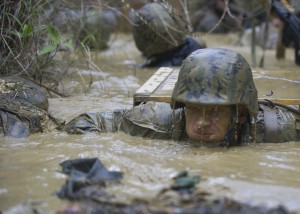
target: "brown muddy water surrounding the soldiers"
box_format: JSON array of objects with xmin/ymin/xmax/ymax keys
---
[{"xmin": 0, "ymin": 35, "xmax": 300, "ymax": 213}]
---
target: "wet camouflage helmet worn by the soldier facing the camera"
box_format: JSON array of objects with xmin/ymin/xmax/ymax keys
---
[{"xmin": 171, "ymin": 48, "xmax": 258, "ymax": 117}]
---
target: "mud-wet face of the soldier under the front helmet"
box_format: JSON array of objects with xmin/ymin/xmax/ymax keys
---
[{"xmin": 185, "ymin": 104, "xmax": 232, "ymax": 141}]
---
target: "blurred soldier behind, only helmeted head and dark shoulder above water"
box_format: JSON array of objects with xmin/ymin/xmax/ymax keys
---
[{"xmin": 132, "ymin": 3, "xmax": 206, "ymax": 67}]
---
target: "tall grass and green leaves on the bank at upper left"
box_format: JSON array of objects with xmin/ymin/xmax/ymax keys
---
[{"xmin": 0, "ymin": 0, "xmax": 72, "ymax": 86}]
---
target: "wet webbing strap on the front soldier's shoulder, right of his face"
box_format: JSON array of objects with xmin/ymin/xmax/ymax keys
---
[{"xmin": 259, "ymin": 104, "xmax": 280, "ymax": 143}]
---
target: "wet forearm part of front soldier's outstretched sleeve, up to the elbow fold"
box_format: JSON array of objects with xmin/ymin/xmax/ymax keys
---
[{"xmin": 58, "ymin": 110, "xmax": 126, "ymax": 134}]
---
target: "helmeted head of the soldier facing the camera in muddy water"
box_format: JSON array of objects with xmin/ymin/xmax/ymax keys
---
[{"xmin": 171, "ymin": 48, "xmax": 258, "ymax": 144}]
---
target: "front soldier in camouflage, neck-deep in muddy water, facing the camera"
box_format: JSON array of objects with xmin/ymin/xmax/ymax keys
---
[{"xmin": 59, "ymin": 48, "xmax": 300, "ymax": 146}]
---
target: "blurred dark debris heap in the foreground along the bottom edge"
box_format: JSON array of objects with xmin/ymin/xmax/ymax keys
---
[{"xmin": 56, "ymin": 158, "xmax": 292, "ymax": 214}]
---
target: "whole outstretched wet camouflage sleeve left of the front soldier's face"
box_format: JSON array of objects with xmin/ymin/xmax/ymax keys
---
[{"xmin": 59, "ymin": 102, "xmax": 177, "ymax": 140}]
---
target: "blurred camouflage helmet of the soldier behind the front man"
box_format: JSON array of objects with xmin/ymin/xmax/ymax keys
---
[{"xmin": 132, "ymin": 3, "xmax": 185, "ymax": 57}]
